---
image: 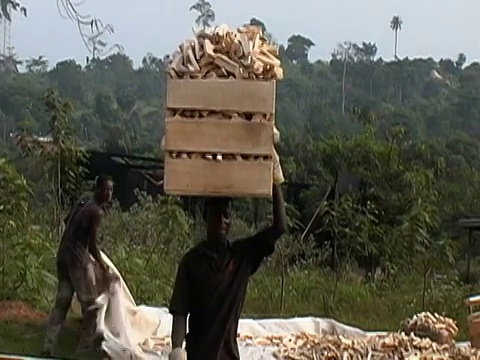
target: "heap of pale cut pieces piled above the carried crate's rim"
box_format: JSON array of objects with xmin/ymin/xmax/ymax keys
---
[{"xmin": 167, "ymin": 25, "xmax": 283, "ymax": 80}]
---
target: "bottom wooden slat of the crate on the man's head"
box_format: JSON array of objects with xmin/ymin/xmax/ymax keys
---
[{"xmin": 164, "ymin": 157, "xmax": 273, "ymax": 198}]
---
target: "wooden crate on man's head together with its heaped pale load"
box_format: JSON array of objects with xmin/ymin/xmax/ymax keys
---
[{"xmin": 162, "ymin": 25, "xmax": 284, "ymax": 197}]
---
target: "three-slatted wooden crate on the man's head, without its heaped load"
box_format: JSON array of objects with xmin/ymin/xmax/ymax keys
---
[{"xmin": 164, "ymin": 79, "xmax": 275, "ymax": 197}]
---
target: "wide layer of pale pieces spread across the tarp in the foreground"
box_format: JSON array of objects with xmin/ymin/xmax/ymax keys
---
[{"xmin": 241, "ymin": 333, "xmax": 480, "ymax": 360}]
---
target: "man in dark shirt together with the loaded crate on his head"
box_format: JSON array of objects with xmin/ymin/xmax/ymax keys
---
[{"xmin": 162, "ymin": 21, "xmax": 286, "ymax": 360}]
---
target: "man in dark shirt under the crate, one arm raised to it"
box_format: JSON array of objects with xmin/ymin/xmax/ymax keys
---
[{"xmin": 170, "ymin": 185, "xmax": 286, "ymax": 360}]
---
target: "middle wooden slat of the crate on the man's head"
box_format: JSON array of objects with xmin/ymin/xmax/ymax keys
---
[{"xmin": 164, "ymin": 118, "xmax": 273, "ymax": 156}]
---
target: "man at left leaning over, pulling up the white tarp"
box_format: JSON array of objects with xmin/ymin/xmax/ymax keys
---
[{"xmin": 43, "ymin": 175, "xmax": 116, "ymax": 356}]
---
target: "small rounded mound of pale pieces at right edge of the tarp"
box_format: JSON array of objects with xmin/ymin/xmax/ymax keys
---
[{"xmin": 400, "ymin": 312, "xmax": 458, "ymax": 344}]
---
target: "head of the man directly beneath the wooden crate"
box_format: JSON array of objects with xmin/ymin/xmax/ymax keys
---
[{"xmin": 204, "ymin": 198, "xmax": 232, "ymax": 240}]
